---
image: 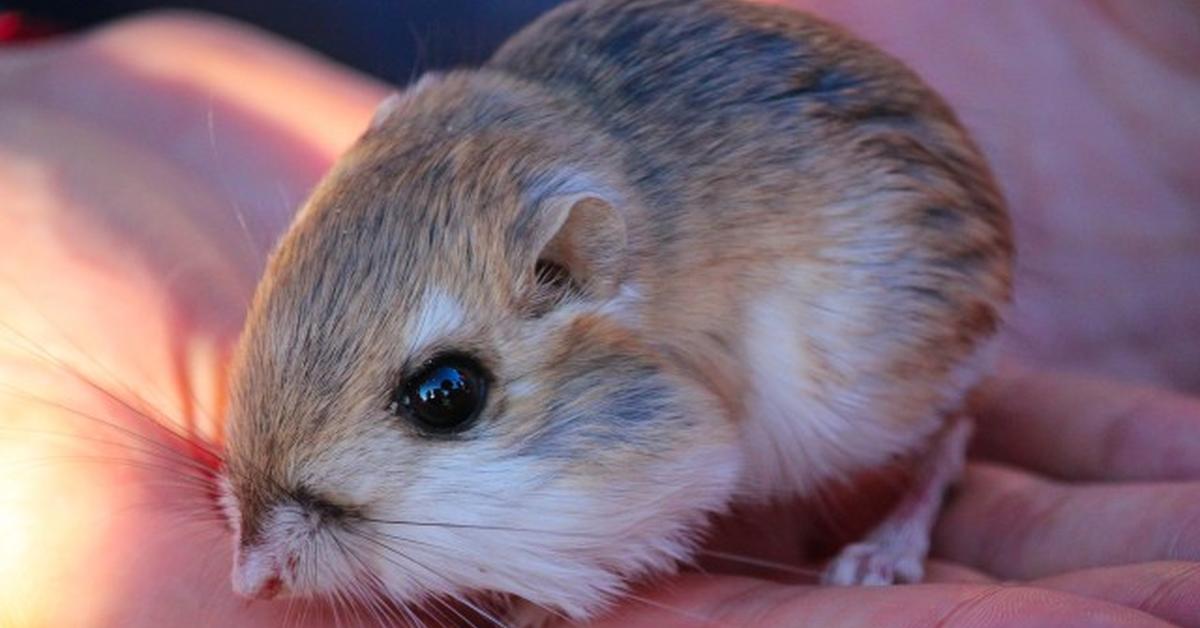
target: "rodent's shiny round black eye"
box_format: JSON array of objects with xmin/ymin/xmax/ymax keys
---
[{"xmin": 390, "ymin": 355, "xmax": 487, "ymax": 432}]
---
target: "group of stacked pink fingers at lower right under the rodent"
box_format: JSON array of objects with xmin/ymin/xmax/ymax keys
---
[{"xmin": 590, "ymin": 367, "xmax": 1200, "ymax": 627}]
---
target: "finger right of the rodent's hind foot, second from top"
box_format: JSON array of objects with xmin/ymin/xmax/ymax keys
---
[{"xmin": 934, "ymin": 463, "xmax": 1200, "ymax": 579}]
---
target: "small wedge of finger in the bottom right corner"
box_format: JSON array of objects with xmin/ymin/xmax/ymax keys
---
[{"xmin": 1031, "ymin": 562, "xmax": 1200, "ymax": 628}]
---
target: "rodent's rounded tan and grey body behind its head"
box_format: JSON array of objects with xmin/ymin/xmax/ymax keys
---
[{"xmin": 488, "ymin": 0, "xmax": 1012, "ymax": 494}]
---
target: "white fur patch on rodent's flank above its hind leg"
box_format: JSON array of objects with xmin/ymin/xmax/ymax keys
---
[{"xmin": 740, "ymin": 283, "xmax": 985, "ymax": 500}]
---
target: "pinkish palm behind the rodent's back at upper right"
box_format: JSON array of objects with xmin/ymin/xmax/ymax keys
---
[{"xmin": 787, "ymin": 0, "xmax": 1200, "ymax": 393}]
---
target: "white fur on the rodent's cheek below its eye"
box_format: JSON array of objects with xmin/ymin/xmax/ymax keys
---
[{"xmin": 340, "ymin": 434, "xmax": 740, "ymax": 618}]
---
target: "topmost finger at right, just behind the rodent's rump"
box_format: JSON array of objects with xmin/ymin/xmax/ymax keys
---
[{"xmin": 972, "ymin": 366, "xmax": 1200, "ymax": 480}]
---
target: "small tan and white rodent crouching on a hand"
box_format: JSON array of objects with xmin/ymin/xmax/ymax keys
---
[{"xmin": 223, "ymin": 0, "xmax": 1013, "ymax": 618}]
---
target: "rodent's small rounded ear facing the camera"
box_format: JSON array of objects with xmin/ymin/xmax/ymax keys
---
[{"xmin": 530, "ymin": 174, "xmax": 626, "ymax": 304}]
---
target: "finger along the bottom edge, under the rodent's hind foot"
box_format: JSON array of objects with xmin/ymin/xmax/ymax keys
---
[{"xmin": 595, "ymin": 576, "xmax": 1169, "ymax": 628}]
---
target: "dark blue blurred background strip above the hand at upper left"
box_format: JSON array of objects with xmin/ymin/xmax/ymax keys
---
[{"xmin": 0, "ymin": 0, "xmax": 560, "ymax": 84}]
